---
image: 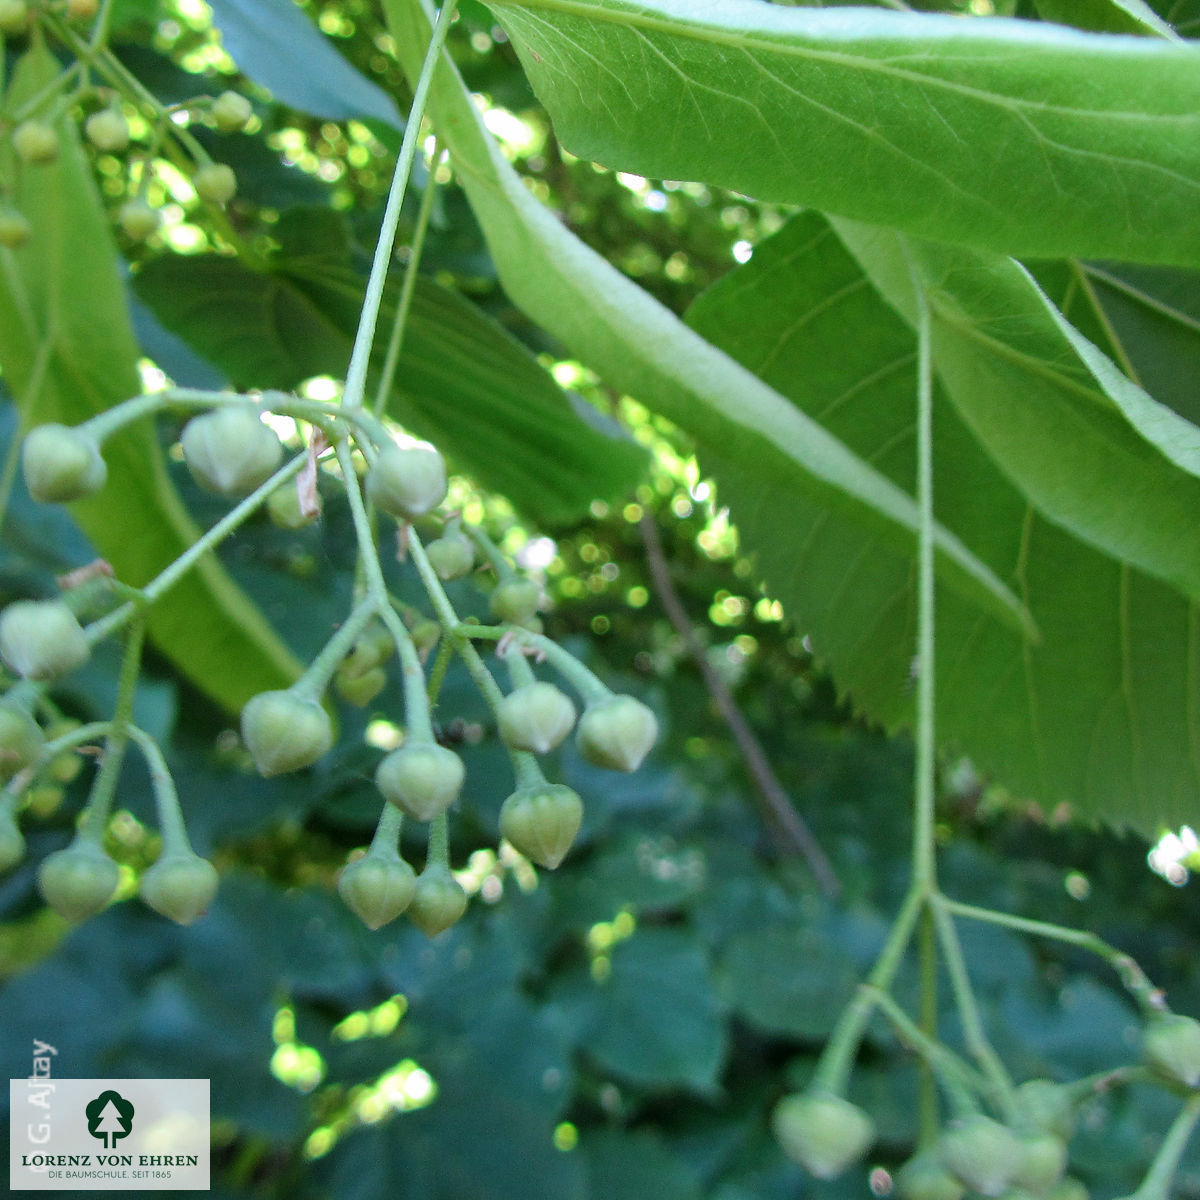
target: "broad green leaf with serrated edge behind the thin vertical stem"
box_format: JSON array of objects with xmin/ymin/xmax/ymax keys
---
[{"xmin": 689, "ymin": 214, "xmax": 1200, "ymax": 833}]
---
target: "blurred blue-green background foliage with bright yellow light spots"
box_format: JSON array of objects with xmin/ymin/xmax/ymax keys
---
[{"xmin": 0, "ymin": 0, "xmax": 1200, "ymax": 1200}]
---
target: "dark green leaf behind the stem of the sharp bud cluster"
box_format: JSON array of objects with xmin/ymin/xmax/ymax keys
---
[{"xmin": 134, "ymin": 223, "xmax": 646, "ymax": 523}]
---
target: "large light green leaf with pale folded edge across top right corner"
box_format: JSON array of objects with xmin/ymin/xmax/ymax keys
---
[{"xmin": 494, "ymin": 0, "xmax": 1200, "ymax": 264}]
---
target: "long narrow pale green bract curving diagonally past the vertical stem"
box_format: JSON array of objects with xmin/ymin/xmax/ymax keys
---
[{"xmin": 385, "ymin": 0, "xmax": 1026, "ymax": 625}]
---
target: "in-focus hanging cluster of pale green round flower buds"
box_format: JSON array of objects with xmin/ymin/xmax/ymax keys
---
[{"xmin": 0, "ymin": 392, "xmax": 658, "ymax": 935}]
